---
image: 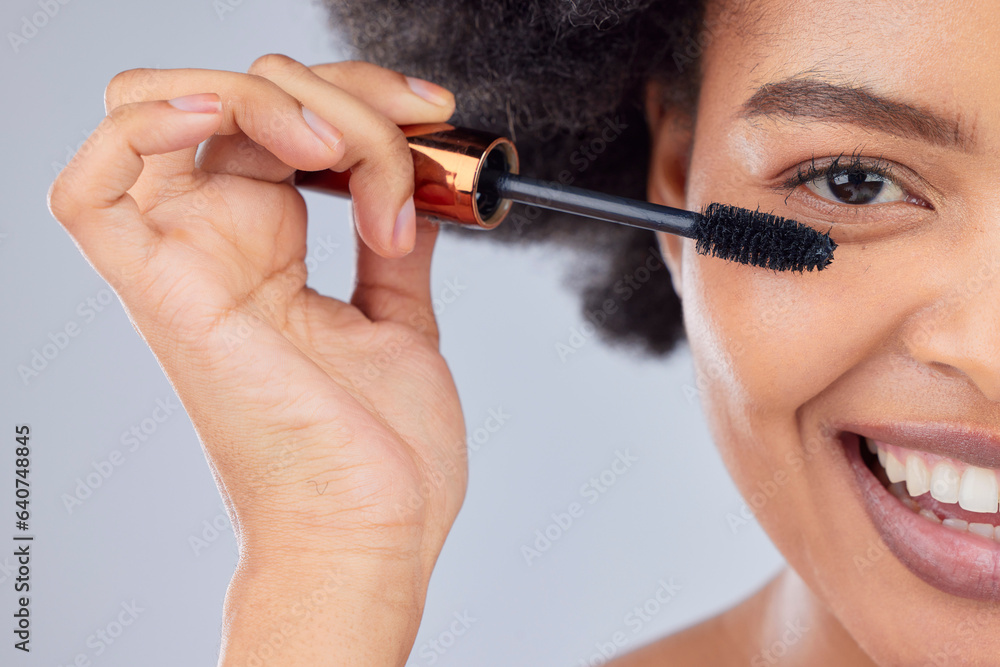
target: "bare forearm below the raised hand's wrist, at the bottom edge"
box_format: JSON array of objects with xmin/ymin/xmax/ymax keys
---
[{"xmin": 219, "ymin": 552, "xmax": 430, "ymax": 667}]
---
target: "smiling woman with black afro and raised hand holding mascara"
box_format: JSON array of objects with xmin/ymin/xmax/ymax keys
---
[{"xmin": 50, "ymin": 0, "xmax": 1000, "ymax": 667}]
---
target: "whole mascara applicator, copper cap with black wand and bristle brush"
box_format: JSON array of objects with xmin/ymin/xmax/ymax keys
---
[{"xmin": 295, "ymin": 123, "xmax": 837, "ymax": 272}]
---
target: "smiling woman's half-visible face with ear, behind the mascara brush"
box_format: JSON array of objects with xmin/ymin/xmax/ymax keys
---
[{"xmin": 649, "ymin": 0, "xmax": 1000, "ymax": 665}]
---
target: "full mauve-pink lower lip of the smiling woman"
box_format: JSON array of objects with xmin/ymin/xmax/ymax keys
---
[{"xmin": 842, "ymin": 433, "xmax": 1000, "ymax": 602}]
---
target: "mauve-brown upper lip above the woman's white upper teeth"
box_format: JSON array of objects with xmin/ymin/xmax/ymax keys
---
[{"xmin": 837, "ymin": 421, "xmax": 1000, "ymax": 468}]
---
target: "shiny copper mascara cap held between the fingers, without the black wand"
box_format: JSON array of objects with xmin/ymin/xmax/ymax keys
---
[{"xmin": 295, "ymin": 123, "xmax": 518, "ymax": 229}]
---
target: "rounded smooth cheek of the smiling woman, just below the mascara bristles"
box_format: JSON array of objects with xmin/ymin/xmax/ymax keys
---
[{"xmin": 682, "ymin": 242, "xmax": 919, "ymax": 436}]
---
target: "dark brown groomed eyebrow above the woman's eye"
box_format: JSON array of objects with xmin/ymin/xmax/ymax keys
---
[{"xmin": 741, "ymin": 78, "xmax": 973, "ymax": 148}]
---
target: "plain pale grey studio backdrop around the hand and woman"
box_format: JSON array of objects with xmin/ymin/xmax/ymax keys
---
[{"xmin": 0, "ymin": 0, "xmax": 782, "ymax": 667}]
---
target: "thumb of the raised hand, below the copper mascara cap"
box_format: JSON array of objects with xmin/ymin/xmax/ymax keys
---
[{"xmin": 351, "ymin": 203, "xmax": 439, "ymax": 347}]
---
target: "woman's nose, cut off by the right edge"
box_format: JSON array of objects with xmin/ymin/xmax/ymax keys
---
[{"xmin": 905, "ymin": 256, "xmax": 1000, "ymax": 402}]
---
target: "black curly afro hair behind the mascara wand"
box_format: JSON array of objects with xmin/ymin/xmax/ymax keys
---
[{"xmin": 324, "ymin": 0, "xmax": 704, "ymax": 355}]
